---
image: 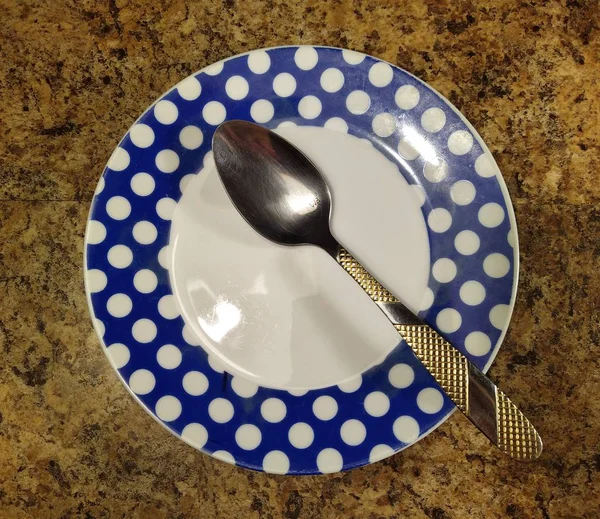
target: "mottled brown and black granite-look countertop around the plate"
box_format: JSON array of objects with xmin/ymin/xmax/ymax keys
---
[{"xmin": 0, "ymin": 0, "xmax": 600, "ymax": 519}]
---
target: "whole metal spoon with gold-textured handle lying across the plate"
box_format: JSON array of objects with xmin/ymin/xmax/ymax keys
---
[{"xmin": 213, "ymin": 121, "xmax": 542, "ymax": 460}]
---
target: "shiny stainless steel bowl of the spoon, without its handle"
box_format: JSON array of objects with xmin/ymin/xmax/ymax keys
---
[{"xmin": 213, "ymin": 121, "xmax": 338, "ymax": 254}]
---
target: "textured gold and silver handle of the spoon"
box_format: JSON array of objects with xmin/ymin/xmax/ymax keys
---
[{"xmin": 336, "ymin": 247, "xmax": 542, "ymax": 461}]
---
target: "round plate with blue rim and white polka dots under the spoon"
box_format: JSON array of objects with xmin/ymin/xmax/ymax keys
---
[{"xmin": 85, "ymin": 47, "xmax": 518, "ymax": 474}]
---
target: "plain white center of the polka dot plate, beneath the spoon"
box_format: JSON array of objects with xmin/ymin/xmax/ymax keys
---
[{"xmin": 169, "ymin": 127, "xmax": 430, "ymax": 390}]
